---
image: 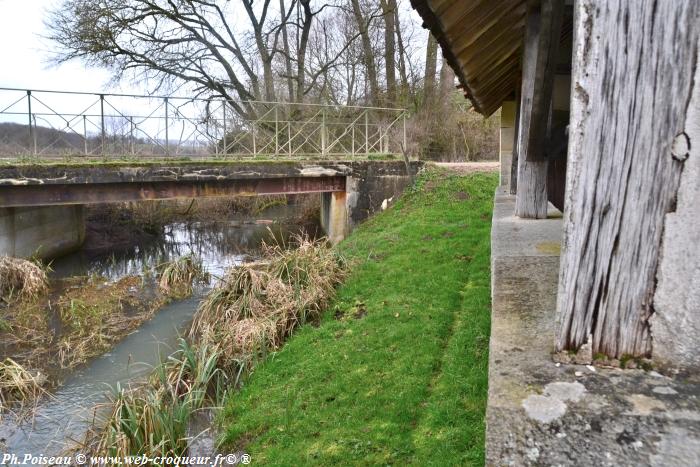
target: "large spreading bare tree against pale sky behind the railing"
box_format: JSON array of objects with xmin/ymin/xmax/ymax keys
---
[{"xmin": 47, "ymin": 0, "xmax": 359, "ymax": 115}]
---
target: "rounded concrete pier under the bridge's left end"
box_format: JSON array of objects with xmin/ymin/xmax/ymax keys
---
[{"xmin": 0, "ymin": 204, "xmax": 85, "ymax": 259}]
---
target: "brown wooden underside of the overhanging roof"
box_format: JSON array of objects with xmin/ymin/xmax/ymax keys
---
[{"xmin": 411, "ymin": 0, "xmax": 527, "ymax": 116}]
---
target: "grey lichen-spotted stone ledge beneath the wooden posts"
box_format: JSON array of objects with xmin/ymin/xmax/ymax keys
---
[{"xmin": 486, "ymin": 191, "xmax": 700, "ymax": 466}]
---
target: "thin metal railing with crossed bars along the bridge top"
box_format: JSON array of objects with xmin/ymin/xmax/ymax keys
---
[{"xmin": 0, "ymin": 87, "xmax": 407, "ymax": 158}]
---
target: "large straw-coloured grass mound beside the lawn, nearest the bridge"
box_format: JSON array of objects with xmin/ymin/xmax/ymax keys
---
[{"xmin": 190, "ymin": 236, "xmax": 344, "ymax": 372}]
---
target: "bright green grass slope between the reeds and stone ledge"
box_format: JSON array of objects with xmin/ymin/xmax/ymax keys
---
[{"xmin": 221, "ymin": 169, "xmax": 497, "ymax": 465}]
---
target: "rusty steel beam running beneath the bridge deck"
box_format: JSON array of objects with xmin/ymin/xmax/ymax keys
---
[{"xmin": 0, "ymin": 176, "xmax": 345, "ymax": 207}]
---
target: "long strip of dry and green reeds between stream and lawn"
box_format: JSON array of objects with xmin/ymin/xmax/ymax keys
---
[{"xmin": 84, "ymin": 236, "xmax": 345, "ymax": 456}]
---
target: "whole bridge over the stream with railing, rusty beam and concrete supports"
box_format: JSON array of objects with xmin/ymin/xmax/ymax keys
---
[{"xmin": 0, "ymin": 88, "xmax": 420, "ymax": 258}]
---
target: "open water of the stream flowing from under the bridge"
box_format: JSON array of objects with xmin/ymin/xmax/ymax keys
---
[{"xmin": 0, "ymin": 207, "xmax": 316, "ymax": 458}]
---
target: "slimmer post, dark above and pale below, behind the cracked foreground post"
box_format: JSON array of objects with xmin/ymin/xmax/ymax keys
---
[{"xmin": 515, "ymin": 0, "xmax": 563, "ymax": 219}]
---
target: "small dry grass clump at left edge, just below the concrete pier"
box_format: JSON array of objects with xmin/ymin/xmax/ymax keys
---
[{"xmin": 0, "ymin": 256, "xmax": 48, "ymax": 304}]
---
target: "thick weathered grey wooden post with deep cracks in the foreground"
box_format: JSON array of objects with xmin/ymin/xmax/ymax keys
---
[{"xmin": 557, "ymin": 0, "xmax": 700, "ymax": 358}]
